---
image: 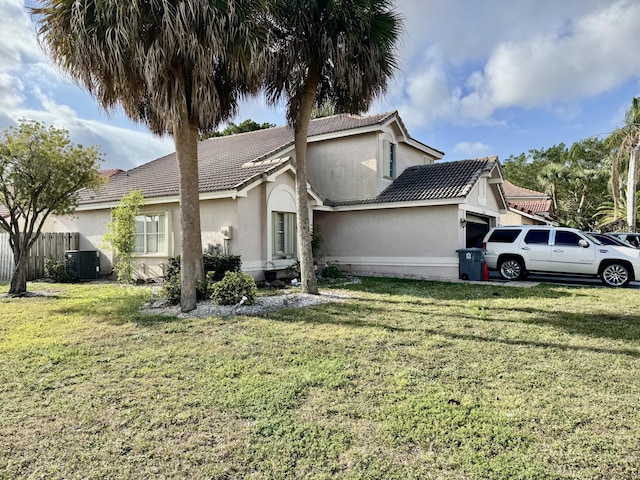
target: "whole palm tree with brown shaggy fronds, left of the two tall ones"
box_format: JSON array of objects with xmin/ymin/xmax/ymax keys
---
[{"xmin": 32, "ymin": 0, "xmax": 259, "ymax": 311}]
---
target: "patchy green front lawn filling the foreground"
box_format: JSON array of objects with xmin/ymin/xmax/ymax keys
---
[{"xmin": 0, "ymin": 279, "xmax": 640, "ymax": 479}]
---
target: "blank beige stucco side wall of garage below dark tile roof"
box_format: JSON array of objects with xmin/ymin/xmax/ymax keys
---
[{"xmin": 315, "ymin": 205, "xmax": 465, "ymax": 278}]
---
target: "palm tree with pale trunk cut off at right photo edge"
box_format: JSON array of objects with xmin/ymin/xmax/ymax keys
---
[{"xmin": 607, "ymin": 97, "xmax": 640, "ymax": 232}]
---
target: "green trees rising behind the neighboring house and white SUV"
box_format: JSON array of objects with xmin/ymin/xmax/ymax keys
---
[{"xmin": 504, "ymin": 137, "xmax": 611, "ymax": 230}]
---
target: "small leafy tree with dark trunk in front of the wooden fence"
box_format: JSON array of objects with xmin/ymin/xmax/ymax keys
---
[{"xmin": 0, "ymin": 121, "xmax": 103, "ymax": 296}]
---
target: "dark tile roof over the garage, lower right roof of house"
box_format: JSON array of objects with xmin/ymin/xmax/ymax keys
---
[{"xmin": 325, "ymin": 157, "xmax": 499, "ymax": 206}]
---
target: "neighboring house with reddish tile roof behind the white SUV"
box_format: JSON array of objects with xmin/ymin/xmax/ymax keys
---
[{"xmin": 500, "ymin": 180, "xmax": 557, "ymax": 225}]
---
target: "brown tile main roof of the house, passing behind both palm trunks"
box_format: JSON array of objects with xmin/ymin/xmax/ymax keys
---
[{"xmin": 78, "ymin": 112, "xmax": 410, "ymax": 204}]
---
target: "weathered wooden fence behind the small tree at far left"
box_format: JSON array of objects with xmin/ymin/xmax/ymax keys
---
[{"xmin": 0, "ymin": 232, "xmax": 80, "ymax": 282}]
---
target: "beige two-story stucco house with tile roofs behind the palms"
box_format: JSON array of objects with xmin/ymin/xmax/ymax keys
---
[{"xmin": 54, "ymin": 112, "xmax": 507, "ymax": 279}]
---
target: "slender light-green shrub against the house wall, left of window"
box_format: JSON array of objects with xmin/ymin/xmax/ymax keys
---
[{"xmin": 103, "ymin": 190, "xmax": 144, "ymax": 283}]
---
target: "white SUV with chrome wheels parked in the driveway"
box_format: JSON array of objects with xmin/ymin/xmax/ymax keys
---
[{"xmin": 483, "ymin": 225, "xmax": 640, "ymax": 287}]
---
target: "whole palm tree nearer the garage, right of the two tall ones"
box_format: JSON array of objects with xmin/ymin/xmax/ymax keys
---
[{"xmin": 265, "ymin": 0, "xmax": 402, "ymax": 294}]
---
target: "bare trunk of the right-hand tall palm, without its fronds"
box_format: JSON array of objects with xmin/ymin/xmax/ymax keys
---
[{"xmin": 294, "ymin": 64, "xmax": 320, "ymax": 295}]
